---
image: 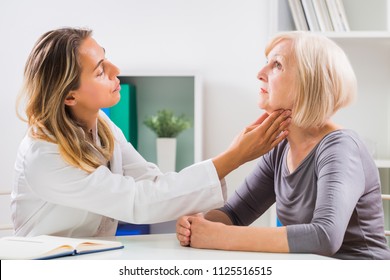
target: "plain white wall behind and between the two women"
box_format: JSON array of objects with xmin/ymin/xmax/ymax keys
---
[{"xmin": 0, "ymin": 0, "xmax": 269, "ymax": 225}]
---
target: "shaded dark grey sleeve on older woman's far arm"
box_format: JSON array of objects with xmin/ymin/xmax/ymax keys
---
[{"xmin": 219, "ymin": 154, "xmax": 275, "ymax": 226}]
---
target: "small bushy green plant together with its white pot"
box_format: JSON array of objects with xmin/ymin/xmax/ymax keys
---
[{"xmin": 144, "ymin": 110, "xmax": 191, "ymax": 172}]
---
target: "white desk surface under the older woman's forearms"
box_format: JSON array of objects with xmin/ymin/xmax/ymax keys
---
[{"xmin": 68, "ymin": 234, "xmax": 331, "ymax": 260}]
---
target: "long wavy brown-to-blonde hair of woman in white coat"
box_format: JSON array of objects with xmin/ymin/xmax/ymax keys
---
[{"xmin": 17, "ymin": 28, "xmax": 114, "ymax": 173}]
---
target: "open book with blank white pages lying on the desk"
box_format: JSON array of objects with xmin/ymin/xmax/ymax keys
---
[{"xmin": 0, "ymin": 235, "xmax": 124, "ymax": 260}]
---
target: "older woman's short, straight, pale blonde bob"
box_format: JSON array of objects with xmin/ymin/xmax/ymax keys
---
[{"xmin": 265, "ymin": 31, "xmax": 357, "ymax": 128}]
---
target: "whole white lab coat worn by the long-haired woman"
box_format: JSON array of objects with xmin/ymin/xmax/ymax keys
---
[{"xmin": 11, "ymin": 113, "xmax": 225, "ymax": 237}]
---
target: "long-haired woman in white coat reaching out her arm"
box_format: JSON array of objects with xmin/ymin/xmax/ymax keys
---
[{"xmin": 11, "ymin": 28, "xmax": 290, "ymax": 237}]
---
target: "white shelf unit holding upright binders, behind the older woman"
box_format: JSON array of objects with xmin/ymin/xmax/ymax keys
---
[{"xmin": 269, "ymin": 0, "xmax": 390, "ymax": 241}]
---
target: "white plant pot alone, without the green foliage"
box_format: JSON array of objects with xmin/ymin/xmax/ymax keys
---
[{"xmin": 157, "ymin": 138, "xmax": 176, "ymax": 173}]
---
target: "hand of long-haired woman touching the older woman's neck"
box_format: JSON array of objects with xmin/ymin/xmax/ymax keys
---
[{"xmin": 213, "ymin": 110, "xmax": 291, "ymax": 179}]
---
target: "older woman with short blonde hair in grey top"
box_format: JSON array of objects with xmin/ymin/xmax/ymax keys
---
[{"xmin": 177, "ymin": 32, "xmax": 390, "ymax": 259}]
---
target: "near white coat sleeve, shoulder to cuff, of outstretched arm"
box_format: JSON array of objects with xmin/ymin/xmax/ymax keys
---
[{"xmin": 24, "ymin": 141, "xmax": 223, "ymax": 223}]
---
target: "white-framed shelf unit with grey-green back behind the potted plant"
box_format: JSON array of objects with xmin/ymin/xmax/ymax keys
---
[{"xmin": 114, "ymin": 71, "xmax": 203, "ymax": 234}]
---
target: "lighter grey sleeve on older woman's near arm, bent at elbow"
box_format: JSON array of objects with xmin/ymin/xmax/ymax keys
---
[{"xmin": 287, "ymin": 137, "xmax": 365, "ymax": 255}]
